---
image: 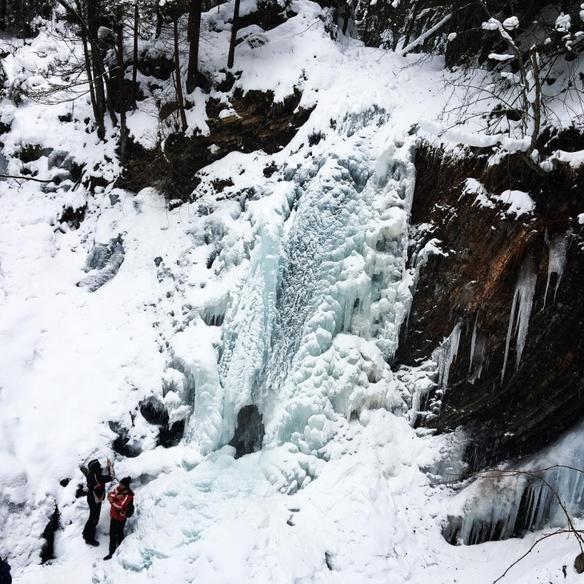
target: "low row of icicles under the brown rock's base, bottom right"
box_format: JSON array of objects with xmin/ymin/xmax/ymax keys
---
[{"xmin": 444, "ymin": 425, "xmax": 584, "ymax": 545}]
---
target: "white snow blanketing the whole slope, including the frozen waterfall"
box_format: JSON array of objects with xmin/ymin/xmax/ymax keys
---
[{"xmin": 0, "ymin": 0, "xmax": 578, "ymax": 584}]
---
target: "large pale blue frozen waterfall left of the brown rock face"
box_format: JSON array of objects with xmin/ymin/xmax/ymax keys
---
[{"xmin": 208, "ymin": 108, "xmax": 414, "ymax": 451}]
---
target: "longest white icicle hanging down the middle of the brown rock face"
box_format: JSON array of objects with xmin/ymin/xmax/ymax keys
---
[{"xmin": 501, "ymin": 257, "xmax": 537, "ymax": 383}]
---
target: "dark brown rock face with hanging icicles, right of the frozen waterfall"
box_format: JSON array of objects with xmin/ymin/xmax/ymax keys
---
[{"xmin": 397, "ymin": 146, "xmax": 584, "ymax": 470}]
